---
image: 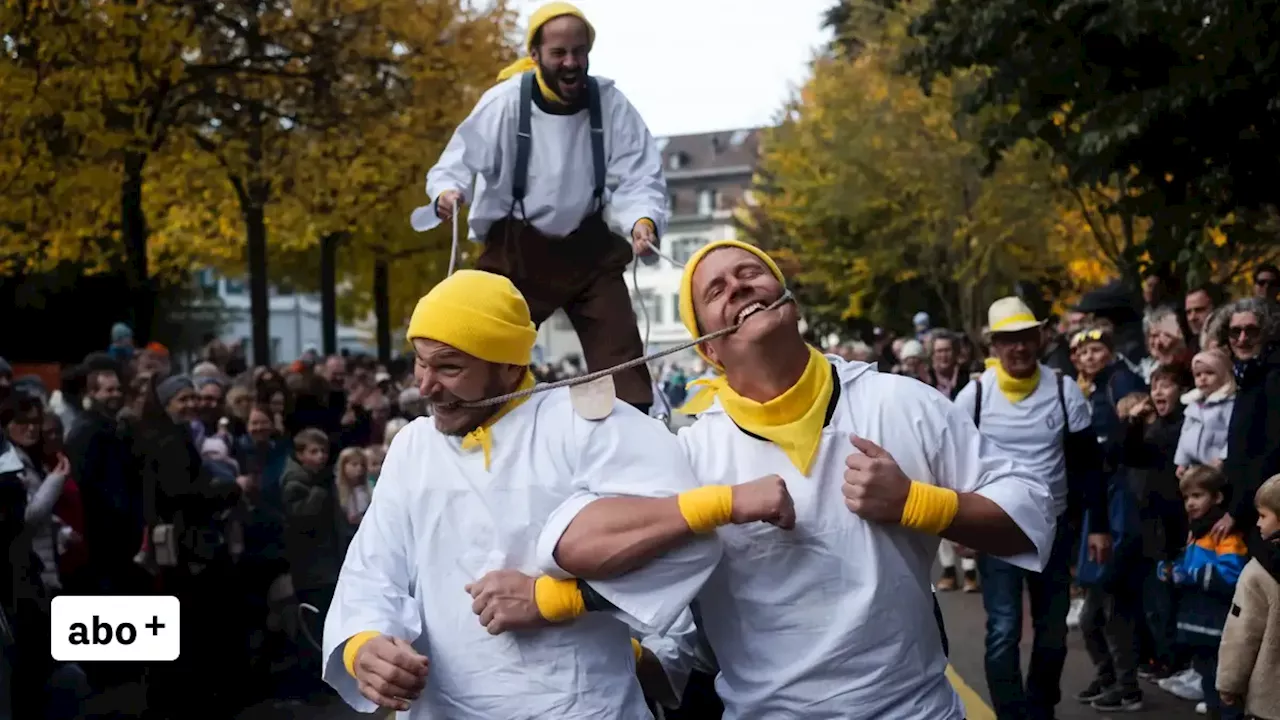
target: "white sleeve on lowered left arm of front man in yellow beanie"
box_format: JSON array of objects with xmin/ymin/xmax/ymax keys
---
[{"xmin": 321, "ymin": 425, "xmax": 424, "ymax": 712}]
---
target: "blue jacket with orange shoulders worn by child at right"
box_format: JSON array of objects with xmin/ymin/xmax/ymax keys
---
[{"xmin": 1157, "ymin": 533, "xmax": 1249, "ymax": 647}]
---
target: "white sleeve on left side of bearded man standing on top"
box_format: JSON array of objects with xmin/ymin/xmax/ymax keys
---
[{"xmin": 410, "ymin": 85, "xmax": 506, "ymax": 232}]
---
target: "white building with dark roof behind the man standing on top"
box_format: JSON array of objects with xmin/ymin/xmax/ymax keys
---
[{"xmin": 536, "ymin": 128, "xmax": 760, "ymax": 363}]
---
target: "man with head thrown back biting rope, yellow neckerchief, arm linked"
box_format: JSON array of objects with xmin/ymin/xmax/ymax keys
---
[{"xmin": 476, "ymin": 241, "xmax": 1053, "ymax": 720}]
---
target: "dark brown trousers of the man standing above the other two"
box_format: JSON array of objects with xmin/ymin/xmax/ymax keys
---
[{"xmin": 476, "ymin": 213, "xmax": 653, "ymax": 411}]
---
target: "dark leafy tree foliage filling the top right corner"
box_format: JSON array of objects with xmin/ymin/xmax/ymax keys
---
[{"xmin": 905, "ymin": 0, "xmax": 1280, "ymax": 281}]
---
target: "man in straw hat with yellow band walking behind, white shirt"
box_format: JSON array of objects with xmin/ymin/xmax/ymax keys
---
[{"xmin": 956, "ymin": 297, "xmax": 1111, "ymax": 720}]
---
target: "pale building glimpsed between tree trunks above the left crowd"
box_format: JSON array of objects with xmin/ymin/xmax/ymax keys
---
[{"xmin": 200, "ymin": 270, "xmax": 376, "ymax": 364}]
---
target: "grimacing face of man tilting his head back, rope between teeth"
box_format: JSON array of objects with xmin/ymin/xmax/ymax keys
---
[{"xmin": 690, "ymin": 247, "xmax": 800, "ymax": 365}]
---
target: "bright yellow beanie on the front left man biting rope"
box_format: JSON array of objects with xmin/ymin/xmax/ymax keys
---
[{"xmin": 404, "ymin": 270, "xmax": 538, "ymax": 365}]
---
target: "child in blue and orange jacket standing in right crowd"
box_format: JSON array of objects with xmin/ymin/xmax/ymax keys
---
[{"xmin": 1157, "ymin": 465, "xmax": 1248, "ymax": 720}]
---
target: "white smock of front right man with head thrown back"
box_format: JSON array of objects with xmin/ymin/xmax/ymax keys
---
[{"xmin": 680, "ymin": 357, "xmax": 1053, "ymax": 720}]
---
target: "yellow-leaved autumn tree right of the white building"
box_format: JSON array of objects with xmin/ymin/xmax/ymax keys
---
[{"xmin": 748, "ymin": 14, "xmax": 1105, "ymax": 331}]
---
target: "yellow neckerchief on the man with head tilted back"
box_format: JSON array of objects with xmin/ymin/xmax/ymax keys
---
[{"xmin": 680, "ymin": 346, "xmax": 835, "ymax": 475}]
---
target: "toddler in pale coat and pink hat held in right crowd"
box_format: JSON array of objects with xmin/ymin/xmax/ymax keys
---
[{"xmin": 1174, "ymin": 350, "xmax": 1235, "ymax": 474}]
